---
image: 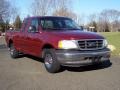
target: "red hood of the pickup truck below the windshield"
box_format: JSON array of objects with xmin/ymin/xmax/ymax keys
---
[{"xmin": 48, "ymin": 30, "xmax": 104, "ymax": 40}]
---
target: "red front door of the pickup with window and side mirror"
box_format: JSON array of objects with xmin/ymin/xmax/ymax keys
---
[{"xmin": 26, "ymin": 18, "xmax": 40, "ymax": 56}]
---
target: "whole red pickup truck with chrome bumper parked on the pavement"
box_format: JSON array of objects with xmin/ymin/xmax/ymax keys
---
[{"xmin": 6, "ymin": 16, "xmax": 110, "ymax": 73}]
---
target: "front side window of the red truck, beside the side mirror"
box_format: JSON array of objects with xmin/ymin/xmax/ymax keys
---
[{"xmin": 28, "ymin": 19, "xmax": 39, "ymax": 32}]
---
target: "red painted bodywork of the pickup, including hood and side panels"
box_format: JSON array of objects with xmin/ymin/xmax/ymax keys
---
[{"xmin": 6, "ymin": 17, "xmax": 104, "ymax": 57}]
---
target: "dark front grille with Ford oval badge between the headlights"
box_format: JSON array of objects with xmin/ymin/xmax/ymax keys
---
[{"xmin": 78, "ymin": 40, "xmax": 103, "ymax": 50}]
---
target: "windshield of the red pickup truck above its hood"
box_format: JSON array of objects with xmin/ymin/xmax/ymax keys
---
[{"xmin": 40, "ymin": 17, "xmax": 80, "ymax": 30}]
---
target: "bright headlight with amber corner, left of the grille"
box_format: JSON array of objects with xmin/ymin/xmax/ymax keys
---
[{"xmin": 58, "ymin": 40, "xmax": 78, "ymax": 49}]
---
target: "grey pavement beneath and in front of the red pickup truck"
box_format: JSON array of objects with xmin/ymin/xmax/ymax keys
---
[{"xmin": 0, "ymin": 37, "xmax": 120, "ymax": 90}]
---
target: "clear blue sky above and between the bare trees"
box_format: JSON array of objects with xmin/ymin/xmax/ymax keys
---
[{"xmin": 10, "ymin": 0, "xmax": 120, "ymax": 18}]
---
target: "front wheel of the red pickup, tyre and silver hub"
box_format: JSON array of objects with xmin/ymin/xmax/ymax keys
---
[{"xmin": 43, "ymin": 49, "xmax": 60, "ymax": 73}]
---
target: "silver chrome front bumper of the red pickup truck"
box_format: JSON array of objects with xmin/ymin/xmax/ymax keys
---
[{"xmin": 56, "ymin": 48, "xmax": 110, "ymax": 67}]
